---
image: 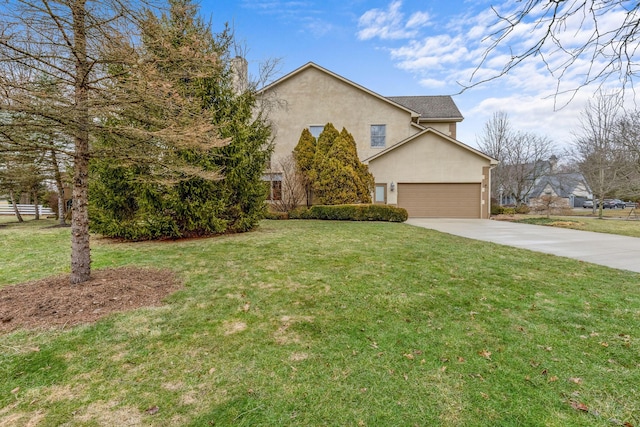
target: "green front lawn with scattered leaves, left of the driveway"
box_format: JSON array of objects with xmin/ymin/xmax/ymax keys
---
[{"xmin": 0, "ymin": 221, "xmax": 640, "ymax": 426}]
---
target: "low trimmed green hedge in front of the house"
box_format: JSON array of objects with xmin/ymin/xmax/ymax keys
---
[{"xmin": 289, "ymin": 204, "xmax": 408, "ymax": 222}]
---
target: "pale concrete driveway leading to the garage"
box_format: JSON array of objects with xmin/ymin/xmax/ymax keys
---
[{"xmin": 407, "ymin": 218, "xmax": 640, "ymax": 273}]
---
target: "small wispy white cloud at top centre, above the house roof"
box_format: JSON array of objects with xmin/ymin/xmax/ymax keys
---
[{"xmin": 357, "ymin": 0, "xmax": 430, "ymax": 40}]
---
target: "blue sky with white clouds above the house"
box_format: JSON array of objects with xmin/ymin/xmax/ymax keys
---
[{"xmin": 200, "ymin": 0, "xmax": 632, "ymax": 148}]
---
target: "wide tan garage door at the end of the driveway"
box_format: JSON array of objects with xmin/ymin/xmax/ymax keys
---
[{"xmin": 398, "ymin": 183, "xmax": 480, "ymax": 218}]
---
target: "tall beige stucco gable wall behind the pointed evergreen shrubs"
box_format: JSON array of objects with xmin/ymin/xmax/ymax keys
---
[{"xmin": 265, "ymin": 67, "xmax": 420, "ymax": 169}]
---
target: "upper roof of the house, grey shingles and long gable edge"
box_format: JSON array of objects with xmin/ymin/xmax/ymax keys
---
[{"xmin": 258, "ymin": 62, "xmax": 464, "ymax": 122}]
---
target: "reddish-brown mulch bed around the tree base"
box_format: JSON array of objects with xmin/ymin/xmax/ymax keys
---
[{"xmin": 0, "ymin": 267, "xmax": 182, "ymax": 334}]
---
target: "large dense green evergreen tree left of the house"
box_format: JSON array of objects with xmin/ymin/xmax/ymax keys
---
[{"xmin": 92, "ymin": 0, "xmax": 271, "ymax": 240}]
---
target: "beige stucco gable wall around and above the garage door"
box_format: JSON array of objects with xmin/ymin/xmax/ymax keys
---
[{"xmin": 369, "ymin": 132, "xmax": 490, "ymax": 208}]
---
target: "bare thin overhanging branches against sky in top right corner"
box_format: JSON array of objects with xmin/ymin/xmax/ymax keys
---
[{"xmin": 476, "ymin": 0, "xmax": 640, "ymax": 98}]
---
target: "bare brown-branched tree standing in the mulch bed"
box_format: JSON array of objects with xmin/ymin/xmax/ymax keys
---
[{"xmin": 0, "ymin": 0, "xmax": 222, "ymax": 284}]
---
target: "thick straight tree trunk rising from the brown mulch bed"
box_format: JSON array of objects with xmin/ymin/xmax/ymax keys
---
[{"xmin": 71, "ymin": 0, "xmax": 91, "ymax": 284}]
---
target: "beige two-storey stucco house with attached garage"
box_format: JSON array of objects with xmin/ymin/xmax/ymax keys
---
[{"xmin": 260, "ymin": 62, "xmax": 497, "ymax": 218}]
